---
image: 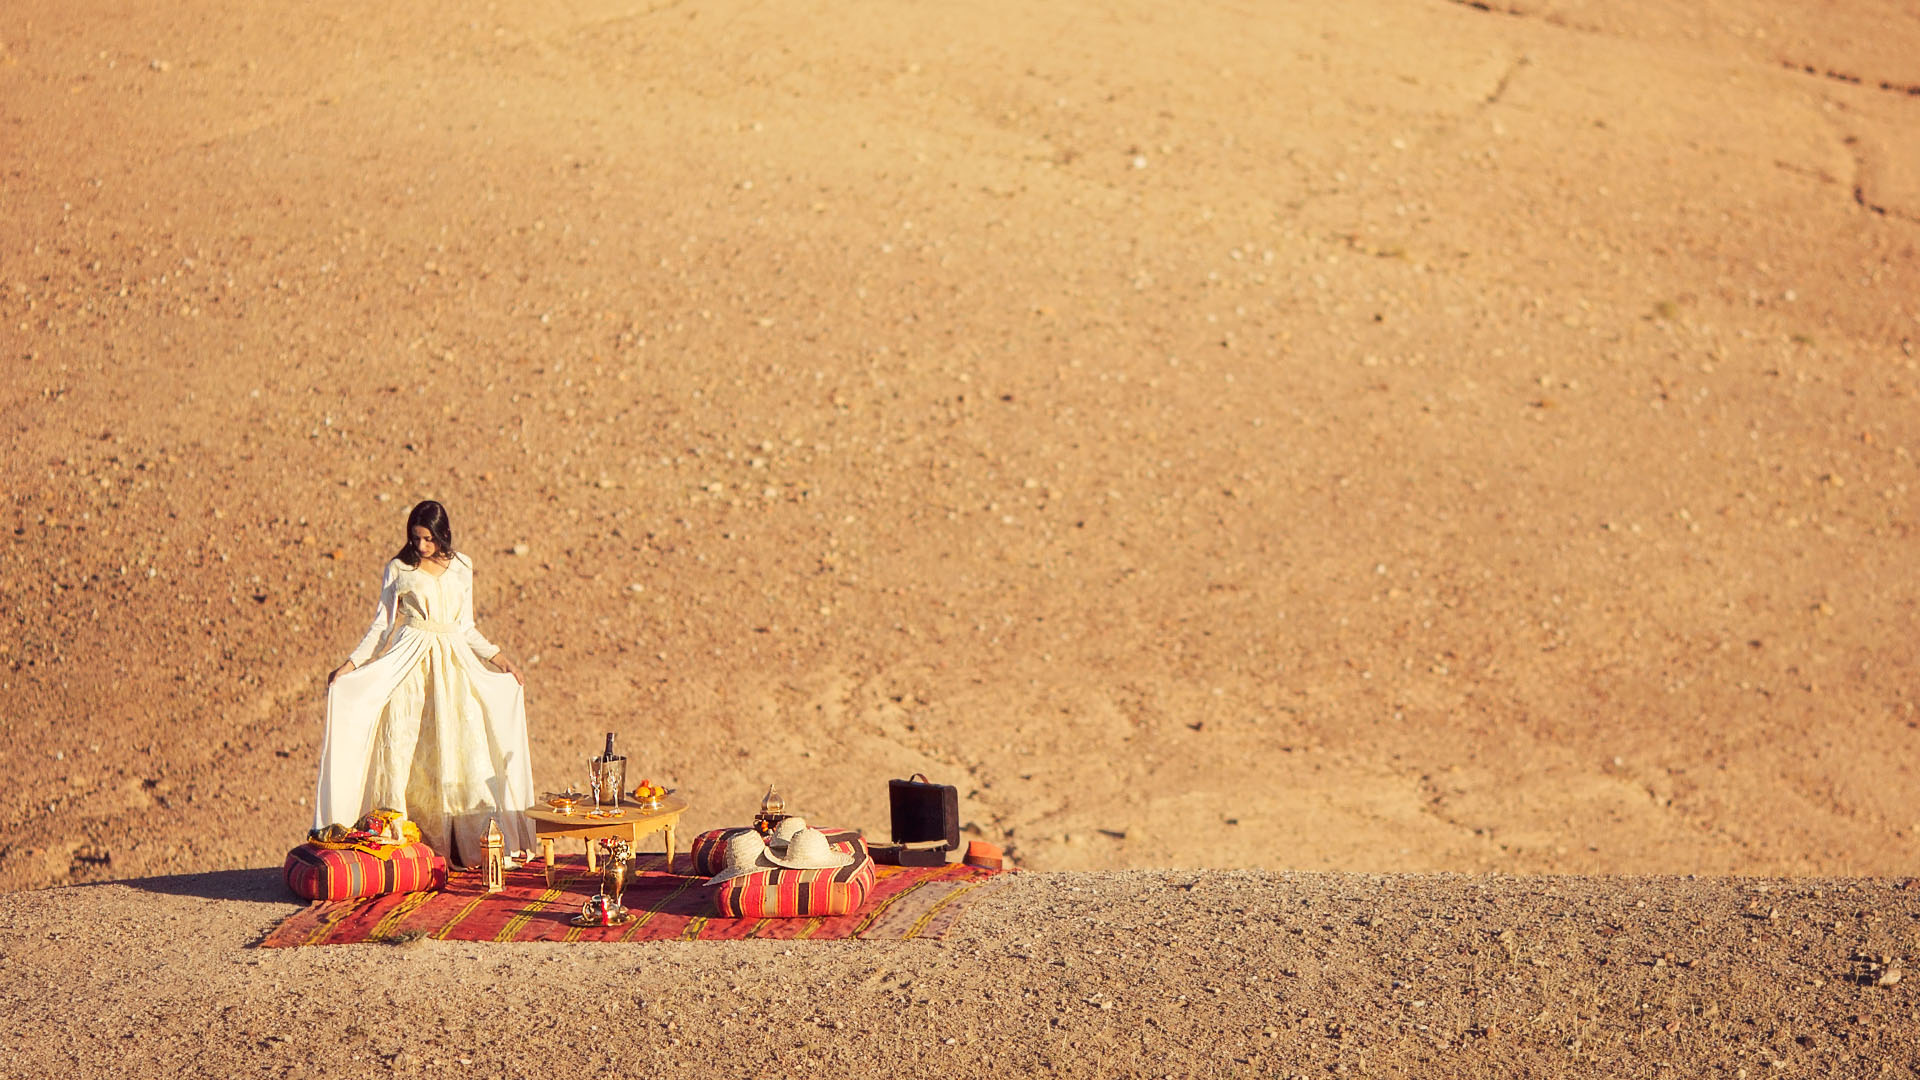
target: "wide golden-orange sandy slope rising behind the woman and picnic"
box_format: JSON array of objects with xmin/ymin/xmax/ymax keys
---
[{"xmin": 0, "ymin": 0, "xmax": 1920, "ymax": 1074}]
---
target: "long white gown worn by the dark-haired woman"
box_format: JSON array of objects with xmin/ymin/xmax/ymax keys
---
[{"xmin": 313, "ymin": 555, "xmax": 534, "ymax": 865}]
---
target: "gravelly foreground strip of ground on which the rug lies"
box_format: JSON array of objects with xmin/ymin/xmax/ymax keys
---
[{"xmin": 0, "ymin": 869, "xmax": 1920, "ymax": 1080}]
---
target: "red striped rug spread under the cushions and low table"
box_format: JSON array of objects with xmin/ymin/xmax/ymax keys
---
[{"xmin": 261, "ymin": 855, "xmax": 1000, "ymax": 947}]
